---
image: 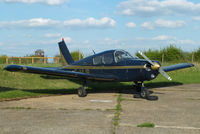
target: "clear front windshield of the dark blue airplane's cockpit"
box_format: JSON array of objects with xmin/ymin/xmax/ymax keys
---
[{"xmin": 115, "ymin": 50, "xmax": 137, "ymax": 62}]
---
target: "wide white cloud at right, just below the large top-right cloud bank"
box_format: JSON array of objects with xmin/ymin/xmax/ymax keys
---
[{"xmin": 141, "ymin": 19, "xmax": 186, "ymax": 30}]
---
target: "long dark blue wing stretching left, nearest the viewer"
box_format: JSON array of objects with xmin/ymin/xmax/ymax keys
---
[{"xmin": 4, "ymin": 65, "xmax": 117, "ymax": 81}]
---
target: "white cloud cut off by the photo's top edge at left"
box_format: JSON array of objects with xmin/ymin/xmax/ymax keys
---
[{"xmin": 2, "ymin": 0, "xmax": 68, "ymax": 5}]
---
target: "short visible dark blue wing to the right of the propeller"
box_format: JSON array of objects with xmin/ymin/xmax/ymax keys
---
[{"xmin": 162, "ymin": 63, "xmax": 194, "ymax": 72}]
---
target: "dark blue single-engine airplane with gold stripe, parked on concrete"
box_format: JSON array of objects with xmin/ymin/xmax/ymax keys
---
[{"xmin": 4, "ymin": 39, "xmax": 194, "ymax": 100}]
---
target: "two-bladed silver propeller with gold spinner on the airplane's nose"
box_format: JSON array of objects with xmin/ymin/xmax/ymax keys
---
[{"xmin": 138, "ymin": 51, "xmax": 172, "ymax": 81}]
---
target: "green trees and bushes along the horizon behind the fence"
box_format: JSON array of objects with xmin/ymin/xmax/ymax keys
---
[{"xmin": 0, "ymin": 45, "xmax": 200, "ymax": 64}]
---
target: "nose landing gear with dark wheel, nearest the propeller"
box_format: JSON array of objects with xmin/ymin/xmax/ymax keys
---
[{"xmin": 133, "ymin": 82, "xmax": 158, "ymax": 100}]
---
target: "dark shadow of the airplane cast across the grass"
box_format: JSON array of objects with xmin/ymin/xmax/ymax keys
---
[{"xmin": 0, "ymin": 82, "xmax": 182, "ymax": 95}]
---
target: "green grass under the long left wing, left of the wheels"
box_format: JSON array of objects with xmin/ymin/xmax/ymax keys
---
[{"xmin": 0, "ymin": 65, "xmax": 80, "ymax": 100}]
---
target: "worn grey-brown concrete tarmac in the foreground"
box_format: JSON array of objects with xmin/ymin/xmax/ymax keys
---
[{"xmin": 0, "ymin": 84, "xmax": 200, "ymax": 134}]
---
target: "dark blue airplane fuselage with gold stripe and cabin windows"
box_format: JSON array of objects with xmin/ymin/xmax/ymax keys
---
[{"xmin": 63, "ymin": 50, "xmax": 160, "ymax": 81}]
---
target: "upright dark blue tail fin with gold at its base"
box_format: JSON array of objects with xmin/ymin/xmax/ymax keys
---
[{"xmin": 58, "ymin": 40, "xmax": 74, "ymax": 65}]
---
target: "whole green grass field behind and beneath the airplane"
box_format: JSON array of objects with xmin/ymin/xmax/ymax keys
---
[{"xmin": 0, "ymin": 64, "xmax": 200, "ymax": 100}]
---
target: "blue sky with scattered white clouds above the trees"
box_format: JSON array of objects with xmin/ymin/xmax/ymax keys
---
[{"xmin": 0, "ymin": 0, "xmax": 200, "ymax": 57}]
